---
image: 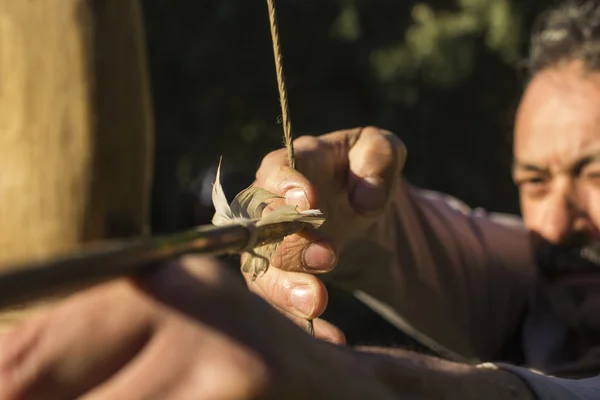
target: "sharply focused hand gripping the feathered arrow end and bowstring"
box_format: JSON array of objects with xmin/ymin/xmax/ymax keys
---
[{"xmin": 246, "ymin": 127, "xmax": 406, "ymax": 343}]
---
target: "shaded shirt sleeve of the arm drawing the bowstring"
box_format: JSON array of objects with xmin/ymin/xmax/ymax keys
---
[{"xmin": 326, "ymin": 182, "xmax": 535, "ymax": 362}]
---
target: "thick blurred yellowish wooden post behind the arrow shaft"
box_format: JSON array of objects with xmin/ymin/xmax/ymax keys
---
[{"xmin": 0, "ymin": 0, "xmax": 153, "ymax": 325}]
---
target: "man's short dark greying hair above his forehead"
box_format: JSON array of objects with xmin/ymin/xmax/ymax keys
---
[{"xmin": 527, "ymin": 0, "xmax": 600, "ymax": 77}]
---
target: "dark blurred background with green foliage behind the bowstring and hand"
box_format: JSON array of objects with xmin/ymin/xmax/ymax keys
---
[{"xmin": 143, "ymin": 0, "xmax": 553, "ymax": 232}]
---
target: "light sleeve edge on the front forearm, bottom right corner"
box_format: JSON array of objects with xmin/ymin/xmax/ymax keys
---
[{"xmin": 497, "ymin": 364, "xmax": 600, "ymax": 400}]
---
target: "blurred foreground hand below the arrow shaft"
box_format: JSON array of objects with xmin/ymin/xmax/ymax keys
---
[{"xmin": 0, "ymin": 257, "xmax": 398, "ymax": 400}]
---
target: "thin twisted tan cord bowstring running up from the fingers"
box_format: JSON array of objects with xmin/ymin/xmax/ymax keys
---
[{"xmin": 267, "ymin": 0, "xmax": 314, "ymax": 336}]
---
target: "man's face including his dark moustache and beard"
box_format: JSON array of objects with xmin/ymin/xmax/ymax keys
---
[{"xmin": 513, "ymin": 62, "xmax": 600, "ymax": 332}]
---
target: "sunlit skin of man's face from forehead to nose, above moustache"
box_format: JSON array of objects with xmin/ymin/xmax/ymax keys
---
[{"xmin": 513, "ymin": 62, "xmax": 600, "ymax": 245}]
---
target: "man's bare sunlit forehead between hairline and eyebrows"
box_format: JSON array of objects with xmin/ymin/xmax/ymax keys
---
[{"xmin": 514, "ymin": 64, "xmax": 600, "ymax": 167}]
